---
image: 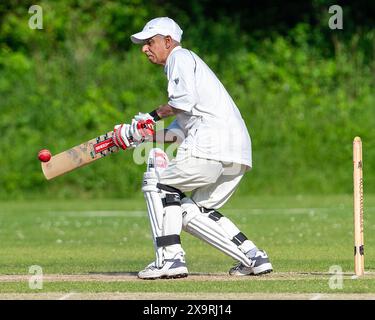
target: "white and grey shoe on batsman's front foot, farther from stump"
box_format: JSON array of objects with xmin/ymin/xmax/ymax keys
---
[{"xmin": 138, "ymin": 259, "xmax": 188, "ymax": 280}]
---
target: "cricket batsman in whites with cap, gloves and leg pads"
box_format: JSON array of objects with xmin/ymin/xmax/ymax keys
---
[{"xmin": 114, "ymin": 17, "xmax": 272, "ymax": 279}]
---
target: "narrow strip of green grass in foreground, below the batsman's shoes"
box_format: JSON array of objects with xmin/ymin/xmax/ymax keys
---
[{"xmin": 0, "ymin": 279, "xmax": 375, "ymax": 293}]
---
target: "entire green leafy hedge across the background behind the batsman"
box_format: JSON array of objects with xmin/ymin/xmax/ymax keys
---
[{"xmin": 0, "ymin": 0, "xmax": 375, "ymax": 199}]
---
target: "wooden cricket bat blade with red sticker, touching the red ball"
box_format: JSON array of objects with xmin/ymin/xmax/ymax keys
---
[{"xmin": 41, "ymin": 131, "xmax": 119, "ymax": 180}]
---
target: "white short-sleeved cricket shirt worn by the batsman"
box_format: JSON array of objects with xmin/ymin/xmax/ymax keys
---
[{"xmin": 164, "ymin": 46, "xmax": 252, "ymax": 167}]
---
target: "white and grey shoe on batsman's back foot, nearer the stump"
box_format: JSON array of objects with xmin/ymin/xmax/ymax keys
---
[{"xmin": 229, "ymin": 250, "xmax": 273, "ymax": 276}]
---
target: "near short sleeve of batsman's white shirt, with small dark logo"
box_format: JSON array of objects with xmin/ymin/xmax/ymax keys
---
[{"xmin": 167, "ymin": 53, "xmax": 198, "ymax": 112}]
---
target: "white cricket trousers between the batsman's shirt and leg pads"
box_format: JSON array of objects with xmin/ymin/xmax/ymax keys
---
[{"xmin": 159, "ymin": 147, "xmax": 248, "ymax": 209}]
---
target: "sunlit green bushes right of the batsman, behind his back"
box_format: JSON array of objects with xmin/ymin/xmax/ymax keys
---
[{"xmin": 223, "ymin": 33, "xmax": 375, "ymax": 193}]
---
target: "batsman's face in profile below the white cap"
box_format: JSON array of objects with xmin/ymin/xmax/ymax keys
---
[{"xmin": 142, "ymin": 35, "xmax": 170, "ymax": 65}]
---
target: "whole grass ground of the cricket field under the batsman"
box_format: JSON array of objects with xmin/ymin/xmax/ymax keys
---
[{"xmin": 0, "ymin": 195, "xmax": 375, "ymax": 298}]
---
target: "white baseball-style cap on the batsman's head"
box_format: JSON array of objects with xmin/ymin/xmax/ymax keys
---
[{"xmin": 130, "ymin": 17, "xmax": 183, "ymax": 43}]
